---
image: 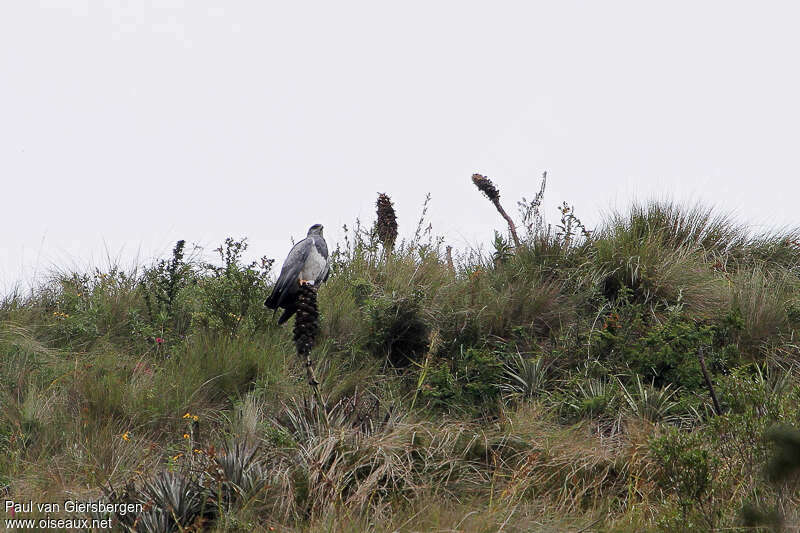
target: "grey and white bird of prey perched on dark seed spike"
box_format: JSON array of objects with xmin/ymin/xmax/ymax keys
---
[{"xmin": 264, "ymin": 224, "xmax": 330, "ymax": 324}]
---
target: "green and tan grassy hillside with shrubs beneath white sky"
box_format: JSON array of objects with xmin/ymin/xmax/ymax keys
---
[{"xmin": 0, "ymin": 181, "xmax": 800, "ymax": 532}]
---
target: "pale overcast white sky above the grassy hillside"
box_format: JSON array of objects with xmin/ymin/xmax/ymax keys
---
[{"xmin": 0, "ymin": 0, "xmax": 800, "ymax": 288}]
